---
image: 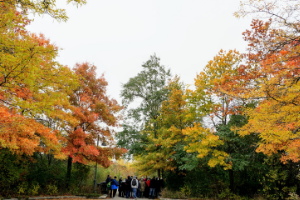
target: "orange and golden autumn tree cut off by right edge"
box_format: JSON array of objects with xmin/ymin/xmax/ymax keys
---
[{"xmin": 219, "ymin": 1, "xmax": 300, "ymax": 162}]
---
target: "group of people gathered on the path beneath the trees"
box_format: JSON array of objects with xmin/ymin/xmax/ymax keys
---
[{"xmin": 106, "ymin": 175, "xmax": 164, "ymax": 199}]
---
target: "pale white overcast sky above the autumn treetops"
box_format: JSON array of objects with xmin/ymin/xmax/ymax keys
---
[{"xmin": 28, "ymin": 0, "xmax": 251, "ymax": 103}]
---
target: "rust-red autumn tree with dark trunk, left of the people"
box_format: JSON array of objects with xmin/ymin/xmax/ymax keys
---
[{"xmin": 63, "ymin": 63, "xmax": 126, "ymax": 188}]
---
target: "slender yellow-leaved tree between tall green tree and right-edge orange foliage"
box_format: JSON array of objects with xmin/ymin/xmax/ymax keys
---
[{"xmin": 184, "ymin": 50, "xmax": 250, "ymax": 191}]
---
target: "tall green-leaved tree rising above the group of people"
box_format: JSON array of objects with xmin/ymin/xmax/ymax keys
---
[{"xmin": 117, "ymin": 55, "xmax": 171, "ymax": 154}]
